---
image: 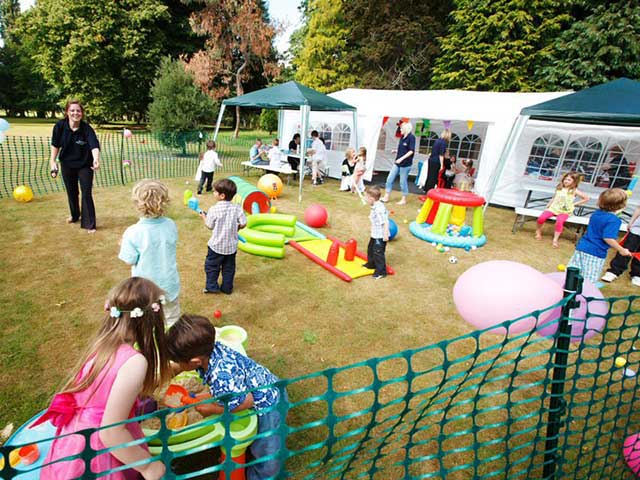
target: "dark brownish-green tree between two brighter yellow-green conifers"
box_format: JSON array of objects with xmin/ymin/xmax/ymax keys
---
[{"xmin": 345, "ymin": 0, "xmax": 452, "ymax": 89}]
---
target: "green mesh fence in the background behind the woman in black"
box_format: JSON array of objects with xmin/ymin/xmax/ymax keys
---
[{"xmin": 0, "ymin": 132, "xmax": 255, "ymax": 198}]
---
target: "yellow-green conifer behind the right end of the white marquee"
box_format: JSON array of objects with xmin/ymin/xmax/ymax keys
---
[{"xmin": 432, "ymin": 0, "xmax": 574, "ymax": 91}]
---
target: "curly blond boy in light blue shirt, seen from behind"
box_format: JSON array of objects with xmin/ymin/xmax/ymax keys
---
[{"xmin": 118, "ymin": 180, "xmax": 180, "ymax": 327}]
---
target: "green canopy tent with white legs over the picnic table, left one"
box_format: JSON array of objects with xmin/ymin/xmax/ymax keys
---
[{"xmin": 213, "ymin": 81, "xmax": 358, "ymax": 201}]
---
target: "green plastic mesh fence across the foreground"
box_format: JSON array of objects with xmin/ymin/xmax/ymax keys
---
[{"xmin": 0, "ymin": 269, "xmax": 640, "ymax": 480}]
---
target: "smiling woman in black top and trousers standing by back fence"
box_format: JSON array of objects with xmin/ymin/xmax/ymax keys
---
[{"xmin": 50, "ymin": 100, "xmax": 100, "ymax": 233}]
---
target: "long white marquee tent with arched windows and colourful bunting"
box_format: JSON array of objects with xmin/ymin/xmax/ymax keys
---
[{"xmin": 279, "ymin": 88, "xmax": 571, "ymax": 206}]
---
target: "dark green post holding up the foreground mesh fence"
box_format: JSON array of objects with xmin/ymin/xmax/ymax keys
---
[{"xmin": 542, "ymin": 267, "xmax": 582, "ymax": 480}]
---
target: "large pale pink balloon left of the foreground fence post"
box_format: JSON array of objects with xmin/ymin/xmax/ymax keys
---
[{"xmin": 453, "ymin": 260, "xmax": 562, "ymax": 335}]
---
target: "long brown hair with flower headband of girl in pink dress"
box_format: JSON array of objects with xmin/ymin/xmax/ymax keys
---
[{"xmin": 63, "ymin": 277, "xmax": 171, "ymax": 395}]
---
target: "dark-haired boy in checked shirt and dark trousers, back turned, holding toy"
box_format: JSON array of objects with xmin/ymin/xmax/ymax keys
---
[{"xmin": 201, "ymin": 178, "xmax": 247, "ymax": 295}]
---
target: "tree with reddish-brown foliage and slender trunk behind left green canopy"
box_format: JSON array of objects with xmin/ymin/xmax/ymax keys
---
[{"xmin": 181, "ymin": 0, "xmax": 279, "ymax": 137}]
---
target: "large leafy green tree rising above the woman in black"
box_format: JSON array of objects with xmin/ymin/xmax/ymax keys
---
[{"xmin": 28, "ymin": 0, "xmax": 168, "ymax": 121}]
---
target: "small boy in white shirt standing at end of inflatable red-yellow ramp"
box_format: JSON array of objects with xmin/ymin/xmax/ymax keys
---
[{"xmin": 363, "ymin": 186, "xmax": 389, "ymax": 280}]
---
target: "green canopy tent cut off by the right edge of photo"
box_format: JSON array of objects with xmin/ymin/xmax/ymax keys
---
[{"xmin": 485, "ymin": 78, "xmax": 640, "ymax": 208}]
